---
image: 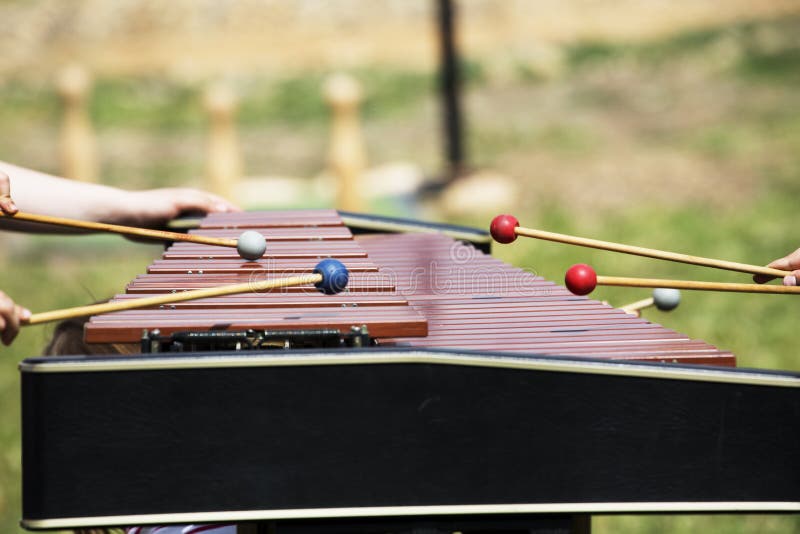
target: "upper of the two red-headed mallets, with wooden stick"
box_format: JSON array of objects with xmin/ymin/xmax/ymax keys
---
[{"xmin": 491, "ymin": 215, "xmax": 792, "ymax": 278}]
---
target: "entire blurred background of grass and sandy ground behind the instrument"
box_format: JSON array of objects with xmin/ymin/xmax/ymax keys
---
[{"xmin": 0, "ymin": 0, "xmax": 800, "ymax": 533}]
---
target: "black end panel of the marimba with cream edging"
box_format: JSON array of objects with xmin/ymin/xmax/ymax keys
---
[{"xmin": 20, "ymin": 348, "xmax": 800, "ymax": 529}]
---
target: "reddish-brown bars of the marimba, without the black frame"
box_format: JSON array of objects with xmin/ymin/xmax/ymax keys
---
[{"xmin": 75, "ymin": 211, "xmax": 735, "ymax": 365}]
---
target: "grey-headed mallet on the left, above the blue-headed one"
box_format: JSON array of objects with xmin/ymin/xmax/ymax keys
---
[{"xmin": 0, "ymin": 211, "xmax": 267, "ymax": 260}]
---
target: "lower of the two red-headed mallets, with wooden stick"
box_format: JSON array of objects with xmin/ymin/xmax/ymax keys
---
[{"xmin": 564, "ymin": 263, "xmax": 800, "ymax": 295}]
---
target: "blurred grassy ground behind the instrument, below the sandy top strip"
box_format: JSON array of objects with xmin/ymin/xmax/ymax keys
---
[{"xmin": 0, "ymin": 14, "xmax": 800, "ymax": 533}]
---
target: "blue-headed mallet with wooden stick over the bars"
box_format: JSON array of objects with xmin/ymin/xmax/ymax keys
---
[{"xmin": 22, "ymin": 258, "xmax": 349, "ymax": 325}]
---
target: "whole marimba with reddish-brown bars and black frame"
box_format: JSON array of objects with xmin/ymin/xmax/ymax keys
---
[{"xmin": 21, "ymin": 210, "xmax": 800, "ymax": 532}]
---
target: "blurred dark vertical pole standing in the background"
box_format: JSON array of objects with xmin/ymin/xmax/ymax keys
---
[{"xmin": 438, "ymin": 0, "xmax": 466, "ymax": 182}]
